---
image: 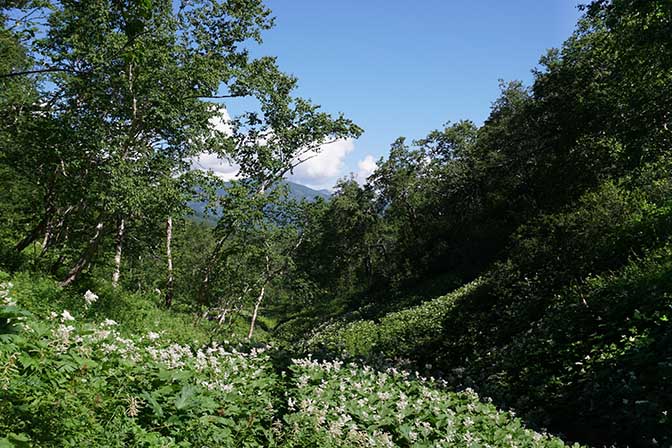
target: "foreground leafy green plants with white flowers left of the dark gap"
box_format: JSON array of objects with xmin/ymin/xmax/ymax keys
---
[{"xmin": 0, "ymin": 298, "xmax": 277, "ymax": 447}]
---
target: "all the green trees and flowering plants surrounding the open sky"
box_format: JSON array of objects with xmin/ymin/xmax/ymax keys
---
[{"xmin": 0, "ymin": 0, "xmax": 672, "ymax": 446}]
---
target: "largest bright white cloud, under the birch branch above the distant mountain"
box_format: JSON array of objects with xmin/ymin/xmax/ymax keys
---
[{"xmin": 289, "ymin": 138, "xmax": 355, "ymax": 189}]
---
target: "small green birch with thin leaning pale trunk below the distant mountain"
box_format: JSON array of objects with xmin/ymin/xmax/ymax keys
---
[{"xmin": 200, "ymin": 181, "xmax": 310, "ymax": 339}]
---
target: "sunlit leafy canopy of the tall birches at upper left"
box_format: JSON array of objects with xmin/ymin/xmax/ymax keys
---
[{"xmin": 0, "ymin": 0, "xmax": 360, "ymax": 285}]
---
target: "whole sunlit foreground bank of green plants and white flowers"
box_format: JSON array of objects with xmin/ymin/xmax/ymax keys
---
[{"xmin": 0, "ymin": 274, "xmax": 576, "ymax": 447}]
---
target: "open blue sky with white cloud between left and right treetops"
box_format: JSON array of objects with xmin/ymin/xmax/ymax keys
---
[{"xmin": 220, "ymin": 0, "xmax": 580, "ymax": 188}]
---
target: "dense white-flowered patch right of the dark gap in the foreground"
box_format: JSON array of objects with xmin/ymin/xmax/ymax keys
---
[{"xmin": 286, "ymin": 358, "xmax": 576, "ymax": 447}]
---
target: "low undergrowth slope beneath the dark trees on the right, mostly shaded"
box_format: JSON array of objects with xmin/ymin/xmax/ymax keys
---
[{"xmin": 300, "ymin": 162, "xmax": 672, "ymax": 446}]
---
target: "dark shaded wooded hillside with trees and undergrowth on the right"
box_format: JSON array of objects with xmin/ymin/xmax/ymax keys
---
[{"xmin": 279, "ymin": 0, "xmax": 672, "ymax": 446}]
